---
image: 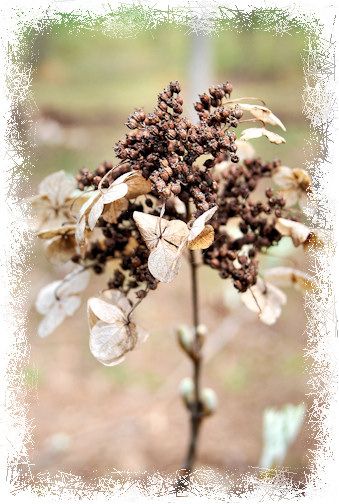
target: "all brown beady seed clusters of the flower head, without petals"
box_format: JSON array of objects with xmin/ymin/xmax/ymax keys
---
[{"xmin": 74, "ymin": 81, "xmax": 294, "ymax": 298}]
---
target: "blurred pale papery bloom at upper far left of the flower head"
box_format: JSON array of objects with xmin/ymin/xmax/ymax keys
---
[{"xmin": 30, "ymin": 170, "xmax": 76, "ymax": 226}]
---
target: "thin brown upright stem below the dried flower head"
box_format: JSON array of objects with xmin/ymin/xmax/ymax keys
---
[{"xmin": 183, "ymin": 250, "xmax": 202, "ymax": 475}]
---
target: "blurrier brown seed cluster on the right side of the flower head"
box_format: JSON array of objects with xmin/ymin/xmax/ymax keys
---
[{"xmin": 204, "ymin": 159, "xmax": 285, "ymax": 292}]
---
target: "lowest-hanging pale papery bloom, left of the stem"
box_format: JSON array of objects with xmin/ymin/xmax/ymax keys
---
[{"xmin": 87, "ymin": 290, "xmax": 147, "ymax": 366}]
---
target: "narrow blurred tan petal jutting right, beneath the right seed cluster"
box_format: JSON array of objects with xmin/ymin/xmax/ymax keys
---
[{"xmin": 264, "ymin": 266, "xmax": 315, "ymax": 292}]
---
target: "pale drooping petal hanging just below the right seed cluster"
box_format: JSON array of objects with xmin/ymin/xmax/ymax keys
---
[{"xmin": 240, "ymin": 277, "xmax": 287, "ymax": 325}]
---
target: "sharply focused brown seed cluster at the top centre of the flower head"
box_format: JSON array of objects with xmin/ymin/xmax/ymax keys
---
[{"xmin": 115, "ymin": 81, "xmax": 242, "ymax": 212}]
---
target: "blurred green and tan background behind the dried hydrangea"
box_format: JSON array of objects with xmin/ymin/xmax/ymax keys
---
[{"xmin": 25, "ymin": 12, "xmax": 313, "ymax": 488}]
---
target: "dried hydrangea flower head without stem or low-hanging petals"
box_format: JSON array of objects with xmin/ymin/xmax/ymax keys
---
[{"xmin": 33, "ymin": 81, "xmax": 311, "ymax": 346}]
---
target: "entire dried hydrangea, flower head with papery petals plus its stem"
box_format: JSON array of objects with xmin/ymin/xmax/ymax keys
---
[{"xmin": 32, "ymin": 81, "xmax": 321, "ymax": 483}]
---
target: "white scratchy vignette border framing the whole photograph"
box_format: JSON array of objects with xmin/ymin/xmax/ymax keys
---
[{"xmin": 0, "ymin": 0, "xmax": 339, "ymax": 503}]
